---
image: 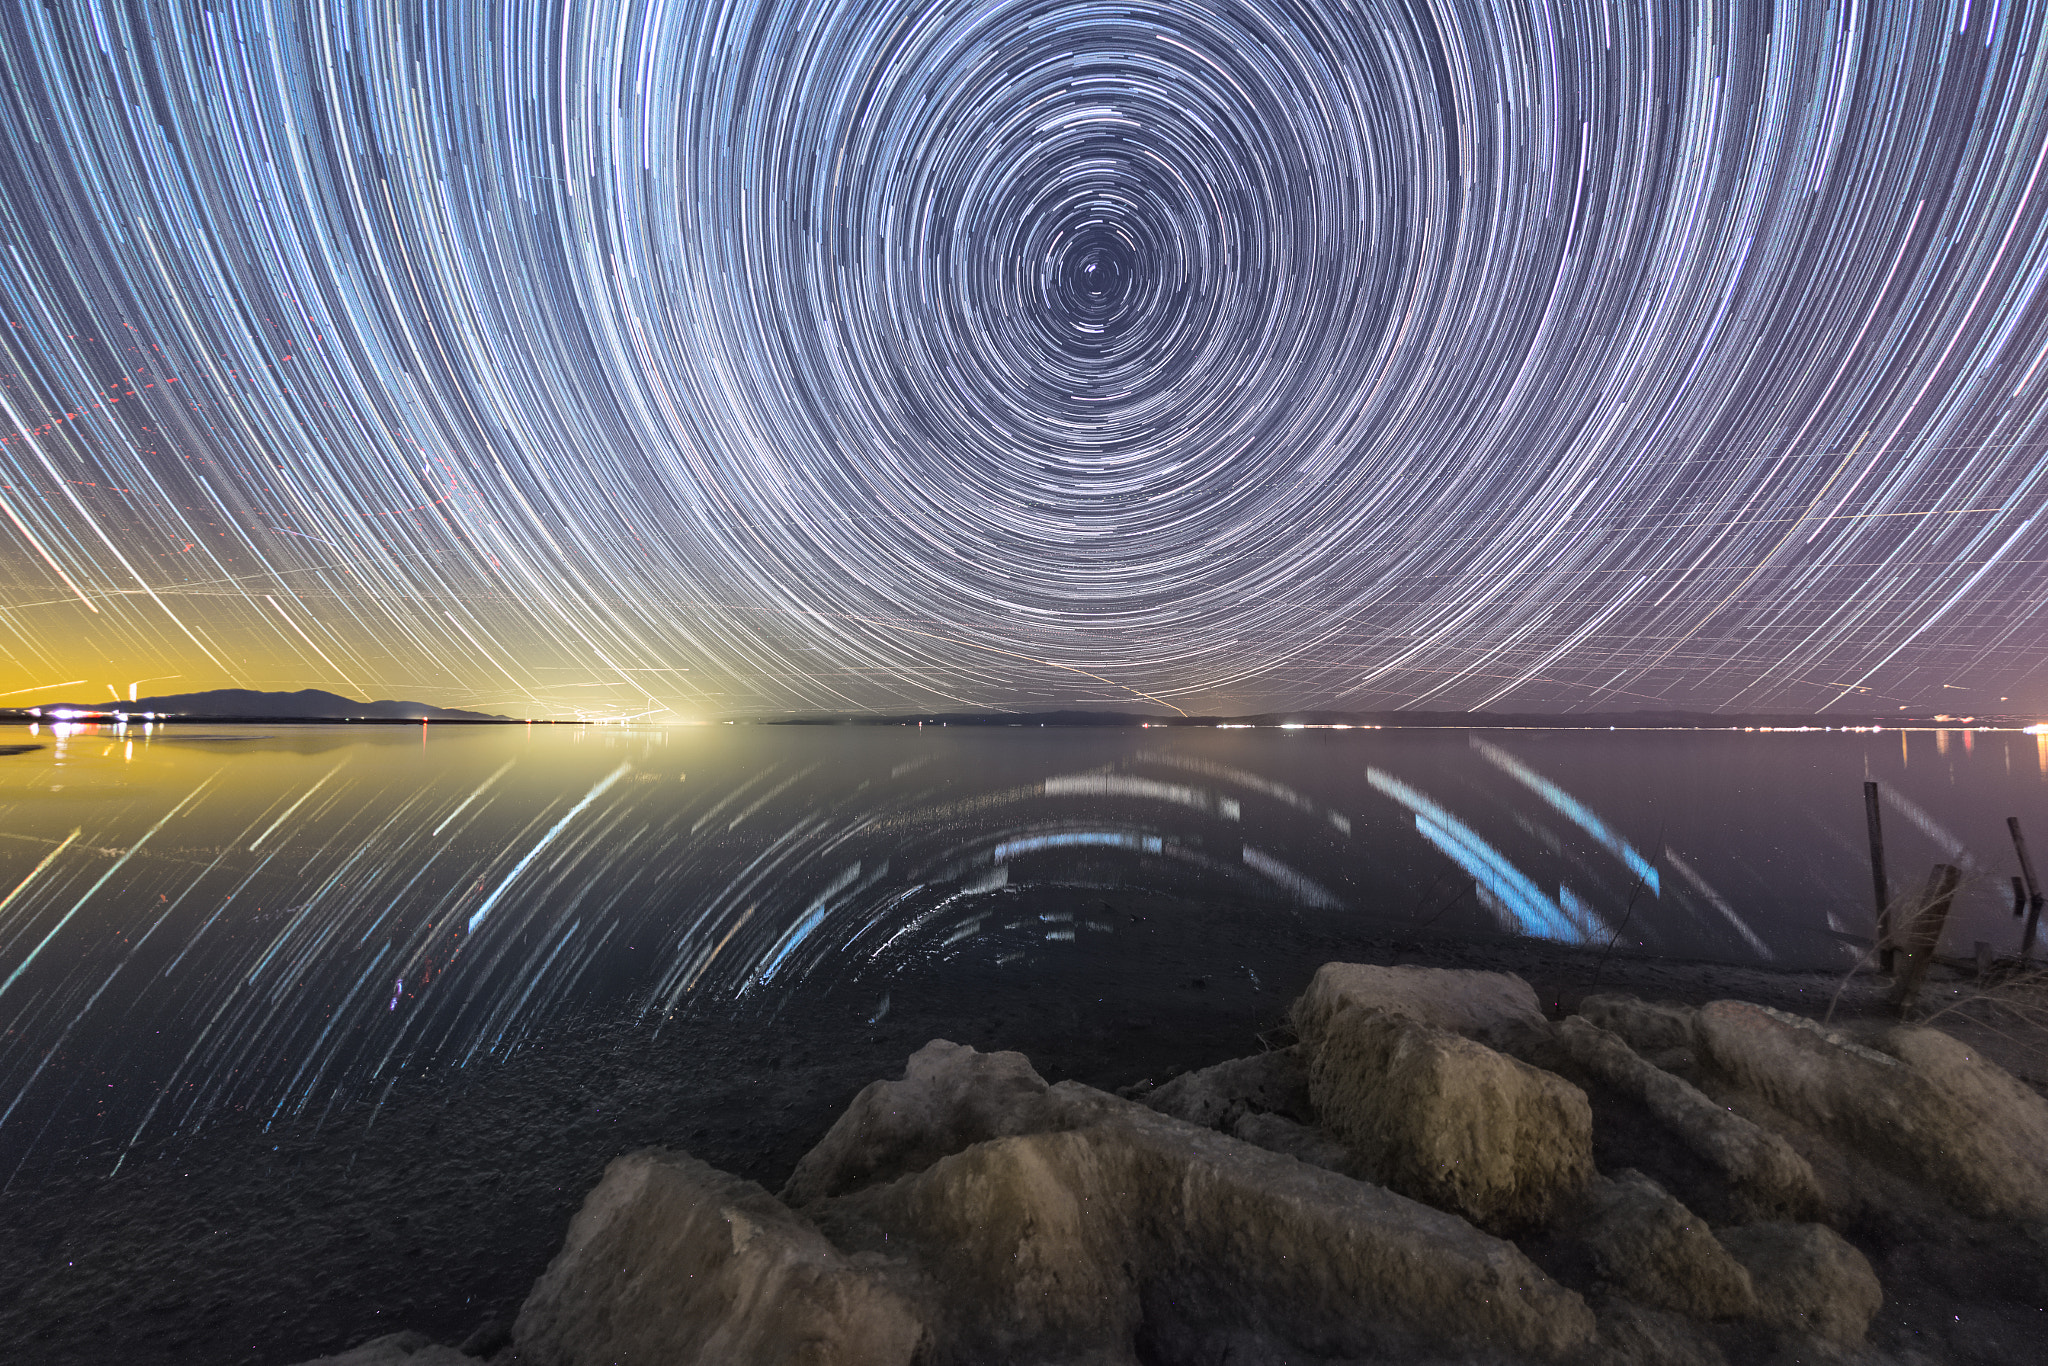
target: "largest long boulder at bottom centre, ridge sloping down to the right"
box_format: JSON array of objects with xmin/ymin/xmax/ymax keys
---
[{"xmin": 815, "ymin": 1081, "xmax": 1593, "ymax": 1364}]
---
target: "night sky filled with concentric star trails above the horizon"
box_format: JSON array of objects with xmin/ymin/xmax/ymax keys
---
[{"xmin": 0, "ymin": 0, "xmax": 2048, "ymax": 719}]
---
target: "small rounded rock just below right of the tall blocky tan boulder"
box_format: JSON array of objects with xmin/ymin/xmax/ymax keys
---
[{"xmin": 1577, "ymin": 1167, "xmax": 1757, "ymax": 1319}]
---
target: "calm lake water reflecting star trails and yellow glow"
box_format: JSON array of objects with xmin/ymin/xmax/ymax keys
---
[{"xmin": 0, "ymin": 725, "xmax": 2048, "ymax": 1182}]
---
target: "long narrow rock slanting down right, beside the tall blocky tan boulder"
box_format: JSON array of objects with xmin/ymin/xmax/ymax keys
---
[{"xmin": 1522, "ymin": 1014, "xmax": 1821, "ymax": 1219}]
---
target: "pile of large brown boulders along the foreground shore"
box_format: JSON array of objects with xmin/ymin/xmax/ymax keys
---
[{"xmin": 292, "ymin": 963, "xmax": 2048, "ymax": 1366}]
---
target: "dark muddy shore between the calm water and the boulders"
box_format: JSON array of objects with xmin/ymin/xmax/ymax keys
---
[{"xmin": 0, "ymin": 889, "xmax": 2048, "ymax": 1366}]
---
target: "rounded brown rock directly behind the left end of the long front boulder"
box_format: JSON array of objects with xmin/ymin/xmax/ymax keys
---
[{"xmin": 782, "ymin": 1038, "xmax": 1056, "ymax": 1206}]
